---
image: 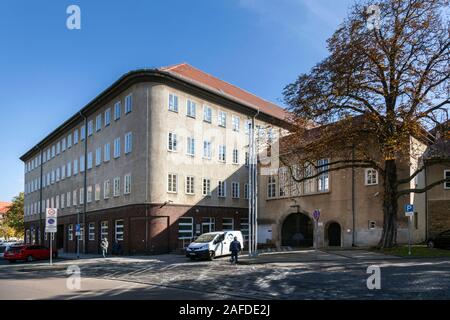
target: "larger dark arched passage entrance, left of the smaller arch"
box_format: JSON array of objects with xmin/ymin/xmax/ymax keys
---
[{"xmin": 281, "ymin": 213, "xmax": 314, "ymax": 247}]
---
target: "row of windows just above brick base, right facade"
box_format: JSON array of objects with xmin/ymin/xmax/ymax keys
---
[{"xmin": 167, "ymin": 173, "xmax": 249, "ymax": 199}]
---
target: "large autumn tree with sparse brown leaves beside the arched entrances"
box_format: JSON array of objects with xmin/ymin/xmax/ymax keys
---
[{"xmin": 283, "ymin": 0, "xmax": 450, "ymax": 247}]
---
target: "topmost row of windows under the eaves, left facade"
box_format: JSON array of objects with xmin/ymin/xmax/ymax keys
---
[{"xmin": 25, "ymin": 93, "xmax": 133, "ymax": 173}]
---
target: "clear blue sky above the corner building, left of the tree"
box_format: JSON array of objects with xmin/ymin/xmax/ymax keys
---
[{"xmin": 0, "ymin": 0, "xmax": 353, "ymax": 201}]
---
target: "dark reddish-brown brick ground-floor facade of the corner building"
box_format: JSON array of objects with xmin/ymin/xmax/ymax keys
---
[{"xmin": 25, "ymin": 204, "xmax": 248, "ymax": 255}]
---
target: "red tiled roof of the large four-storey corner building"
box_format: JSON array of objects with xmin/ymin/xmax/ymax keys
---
[{"xmin": 158, "ymin": 63, "xmax": 287, "ymax": 120}]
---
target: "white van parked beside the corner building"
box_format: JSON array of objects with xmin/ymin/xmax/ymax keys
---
[{"xmin": 186, "ymin": 231, "xmax": 244, "ymax": 260}]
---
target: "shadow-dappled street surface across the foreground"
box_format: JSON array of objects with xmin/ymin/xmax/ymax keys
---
[{"xmin": 0, "ymin": 253, "xmax": 450, "ymax": 300}]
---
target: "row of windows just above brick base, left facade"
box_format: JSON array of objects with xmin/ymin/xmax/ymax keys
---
[{"xmin": 24, "ymin": 174, "xmax": 131, "ymax": 216}]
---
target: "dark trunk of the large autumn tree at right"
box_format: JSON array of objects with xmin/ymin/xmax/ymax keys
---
[{"xmin": 379, "ymin": 160, "xmax": 398, "ymax": 248}]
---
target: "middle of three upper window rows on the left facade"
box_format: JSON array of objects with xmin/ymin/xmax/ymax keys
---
[{"xmin": 25, "ymin": 132, "xmax": 133, "ymax": 194}]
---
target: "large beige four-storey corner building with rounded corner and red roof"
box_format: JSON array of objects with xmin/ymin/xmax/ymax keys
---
[{"xmin": 21, "ymin": 64, "xmax": 287, "ymax": 254}]
